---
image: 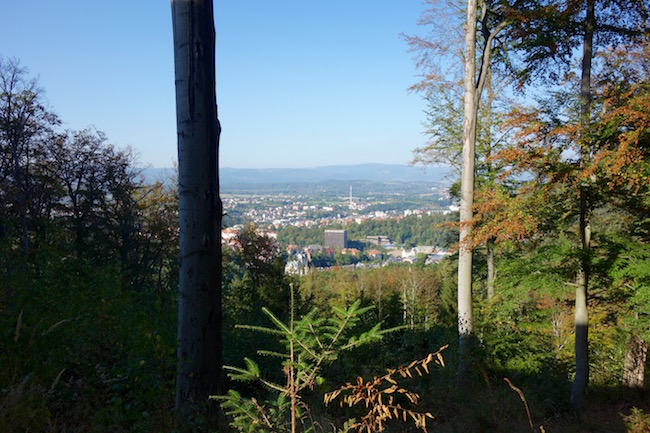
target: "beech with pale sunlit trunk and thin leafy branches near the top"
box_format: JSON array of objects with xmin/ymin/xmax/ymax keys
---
[{"xmin": 407, "ymin": 0, "xmax": 509, "ymax": 371}]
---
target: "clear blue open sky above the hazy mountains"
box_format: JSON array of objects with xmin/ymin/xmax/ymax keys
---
[{"xmin": 0, "ymin": 0, "xmax": 425, "ymax": 168}]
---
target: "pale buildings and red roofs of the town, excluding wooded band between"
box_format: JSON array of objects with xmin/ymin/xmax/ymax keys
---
[{"xmin": 222, "ymin": 186, "xmax": 457, "ymax": 275}]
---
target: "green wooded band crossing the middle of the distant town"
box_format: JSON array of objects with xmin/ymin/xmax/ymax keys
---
[{"xmin": 278, "ymin": 214, "xmax": 458, "ymax": 248}]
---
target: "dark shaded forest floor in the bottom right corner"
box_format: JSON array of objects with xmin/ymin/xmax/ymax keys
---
[{"xmin": 416, "ymin": 377, "xmax": 650, "ymax": 433}]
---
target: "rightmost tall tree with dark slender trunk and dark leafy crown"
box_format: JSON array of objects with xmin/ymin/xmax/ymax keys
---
[{"xmin": 504, "ymin": 0, "xmax": 648, "ymax": 407}]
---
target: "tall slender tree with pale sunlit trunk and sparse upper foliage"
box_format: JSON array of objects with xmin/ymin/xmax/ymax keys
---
[{"xmin": 406, "ymin": 0, "xmax": 511, "ymax": 354}]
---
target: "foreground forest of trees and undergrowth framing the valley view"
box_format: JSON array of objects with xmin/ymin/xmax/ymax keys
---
[{"xmin": 0, "ymin": 0, "xmax": 650, "ymax": 433}]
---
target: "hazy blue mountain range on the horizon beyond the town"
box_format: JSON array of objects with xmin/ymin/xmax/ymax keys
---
[{"xmin": 144, "ymin": 164, "xmax": 451, "ymax": 185}]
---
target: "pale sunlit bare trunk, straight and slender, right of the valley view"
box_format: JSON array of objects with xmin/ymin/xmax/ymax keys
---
[{"xmin": 458, "ymin": 0, "xmax": 478, "ymax": 378}]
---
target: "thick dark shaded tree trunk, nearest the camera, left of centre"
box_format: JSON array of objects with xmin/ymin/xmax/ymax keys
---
[{"xmin": 171, "ymin": 0, "xmax": 222, "ymax": 412}]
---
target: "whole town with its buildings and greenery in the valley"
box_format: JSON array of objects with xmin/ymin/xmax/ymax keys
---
[{"xmin": 221, "ymin": 167, "xmax": 458, "ymax": 274}]
